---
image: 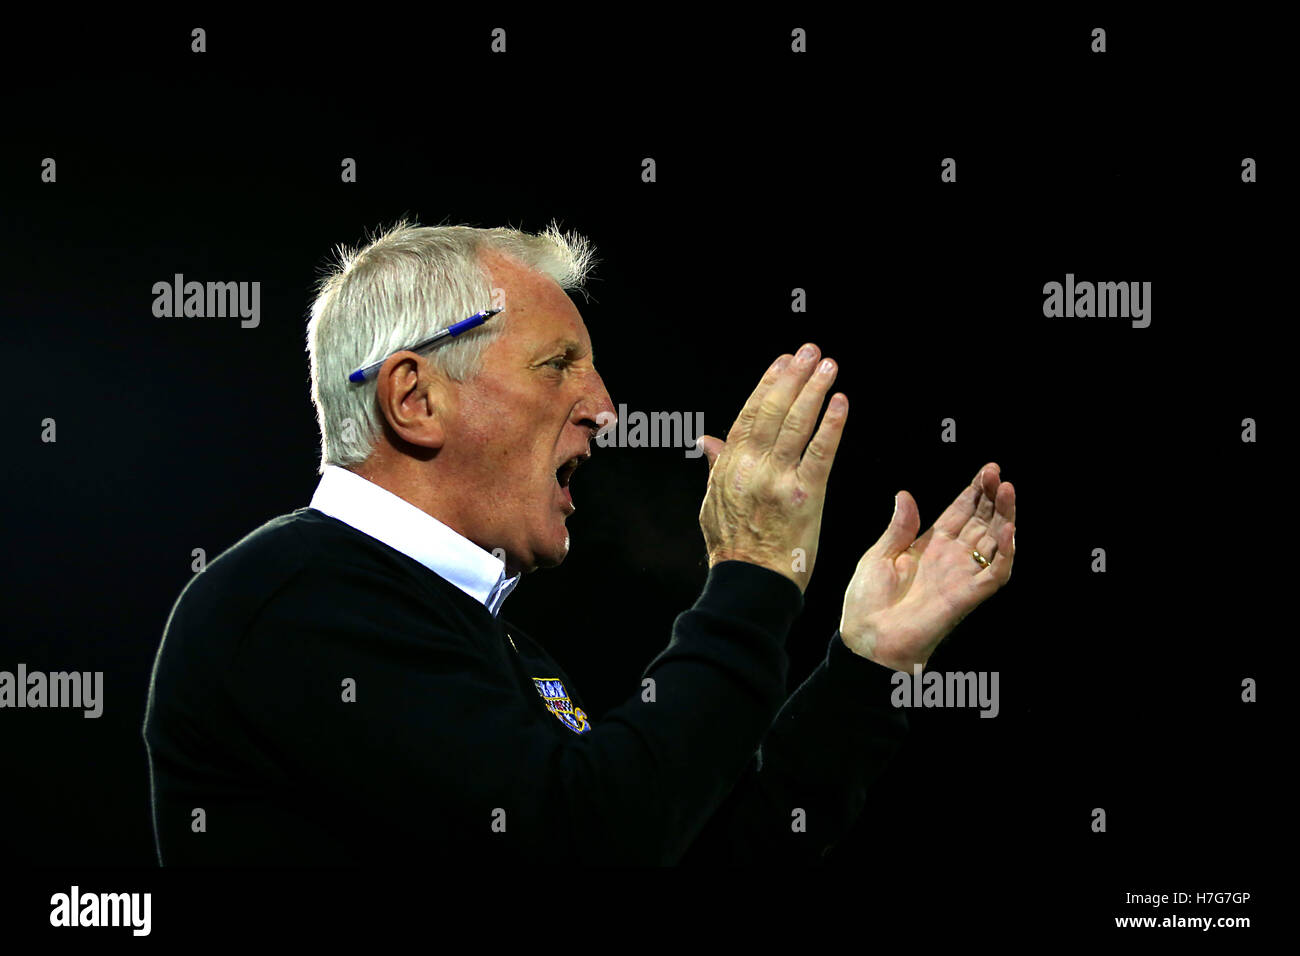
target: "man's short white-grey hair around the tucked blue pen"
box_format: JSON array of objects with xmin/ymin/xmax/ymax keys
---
[{"xmin": 307, "ymin": 220, "xmax": 597, "ymax": 473}]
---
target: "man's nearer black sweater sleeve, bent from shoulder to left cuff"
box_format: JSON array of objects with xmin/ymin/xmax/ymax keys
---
[{"xmin": 226, "ymin": 558, "xmax": 803, "ymax": 865}]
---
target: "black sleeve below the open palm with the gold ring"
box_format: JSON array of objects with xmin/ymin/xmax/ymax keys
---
[{"xmin": 683, "ymin": 631, "xmax": 909, "ymax": 865}]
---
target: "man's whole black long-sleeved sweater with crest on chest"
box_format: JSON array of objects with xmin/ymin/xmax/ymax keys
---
[{"xmin": 144, "ymin": 509, "xmax": 907, "ymax": 865}]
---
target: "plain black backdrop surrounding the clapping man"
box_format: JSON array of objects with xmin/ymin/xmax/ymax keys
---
[{"xmin": 0, "ymin": 8, "xmax": 1294, "ymax": 938}]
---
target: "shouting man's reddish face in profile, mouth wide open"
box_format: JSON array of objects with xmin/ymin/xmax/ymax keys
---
[{"xmin": 439, "ymin": 254, "xmax": 615, "ymax": 574}]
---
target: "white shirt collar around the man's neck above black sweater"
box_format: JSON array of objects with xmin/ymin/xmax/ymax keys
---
[{"xmin": 309, "ymin": 464, "xmax": 523, "ymax": 617}]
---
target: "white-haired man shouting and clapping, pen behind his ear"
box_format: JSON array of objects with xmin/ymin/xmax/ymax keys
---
[{"xmin": 144, "ymin": 222, "xmax": 1015, "ymax": 865}]
